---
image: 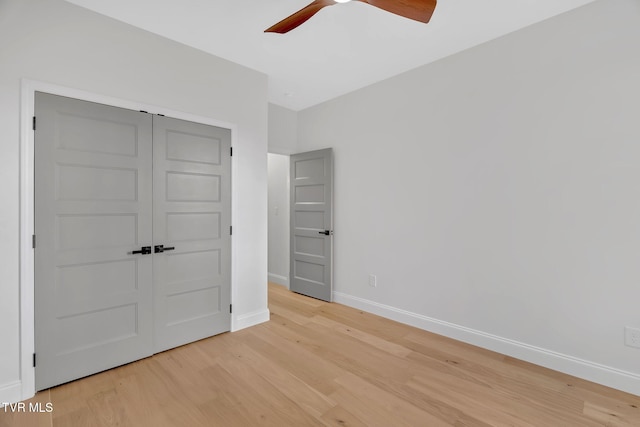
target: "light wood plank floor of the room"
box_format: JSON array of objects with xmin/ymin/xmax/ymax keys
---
[{"xmin": 0, "ymin": 285, "xmax": 640, "ymax": 427}]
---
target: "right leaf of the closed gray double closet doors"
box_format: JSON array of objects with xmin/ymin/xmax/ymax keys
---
[{"xmin": 153, "ymin": 116, "xmax": 231, "ymax": 352}]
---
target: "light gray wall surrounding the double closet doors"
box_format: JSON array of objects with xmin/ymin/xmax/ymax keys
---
[{"xmin": 0, "ymin": 0, "xmax": 268, "ymax": 401}]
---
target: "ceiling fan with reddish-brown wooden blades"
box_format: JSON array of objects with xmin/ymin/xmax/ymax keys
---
[{"xmin": 264, "ymin": 0, "xmax": 437, "ymax": 34}]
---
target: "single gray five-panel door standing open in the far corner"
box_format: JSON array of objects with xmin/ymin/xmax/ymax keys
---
[{"xmin": 289, "ymin": 148, "xmax": 333, "ymax": 301}]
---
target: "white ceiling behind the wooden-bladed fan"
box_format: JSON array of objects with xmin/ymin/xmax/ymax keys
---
[{"xmin": 67, "ymin": 0, "xmax": 594, "ymax": 110}]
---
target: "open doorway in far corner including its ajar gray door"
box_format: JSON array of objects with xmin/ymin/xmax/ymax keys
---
[{"xmin": 268, "ymin": 148, "xmax": 333, "ymax": 301}]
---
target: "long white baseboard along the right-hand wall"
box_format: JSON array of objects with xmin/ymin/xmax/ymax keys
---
[{"xmin": 333, "ymin": 292, "xmax": 640, "ymax": 396}]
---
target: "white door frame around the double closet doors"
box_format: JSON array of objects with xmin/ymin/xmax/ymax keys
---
[{"xmin": 19, "ymin": 79, "xmax": 238, "ymax": 400}]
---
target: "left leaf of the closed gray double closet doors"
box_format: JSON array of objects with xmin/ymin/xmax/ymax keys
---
[{"xmin": 35, "ymin": 93, "xmax": 153, "ymax": 390}]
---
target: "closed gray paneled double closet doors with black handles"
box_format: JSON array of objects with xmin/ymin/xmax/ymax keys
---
[{"xmin": 34, "ymin": 93, "xmax": 231, "ymax": 390}]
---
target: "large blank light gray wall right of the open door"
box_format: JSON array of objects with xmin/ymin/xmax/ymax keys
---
[{"xmin": 298, "ymin": 0, "xmax": 640, "ymax": 394}]
